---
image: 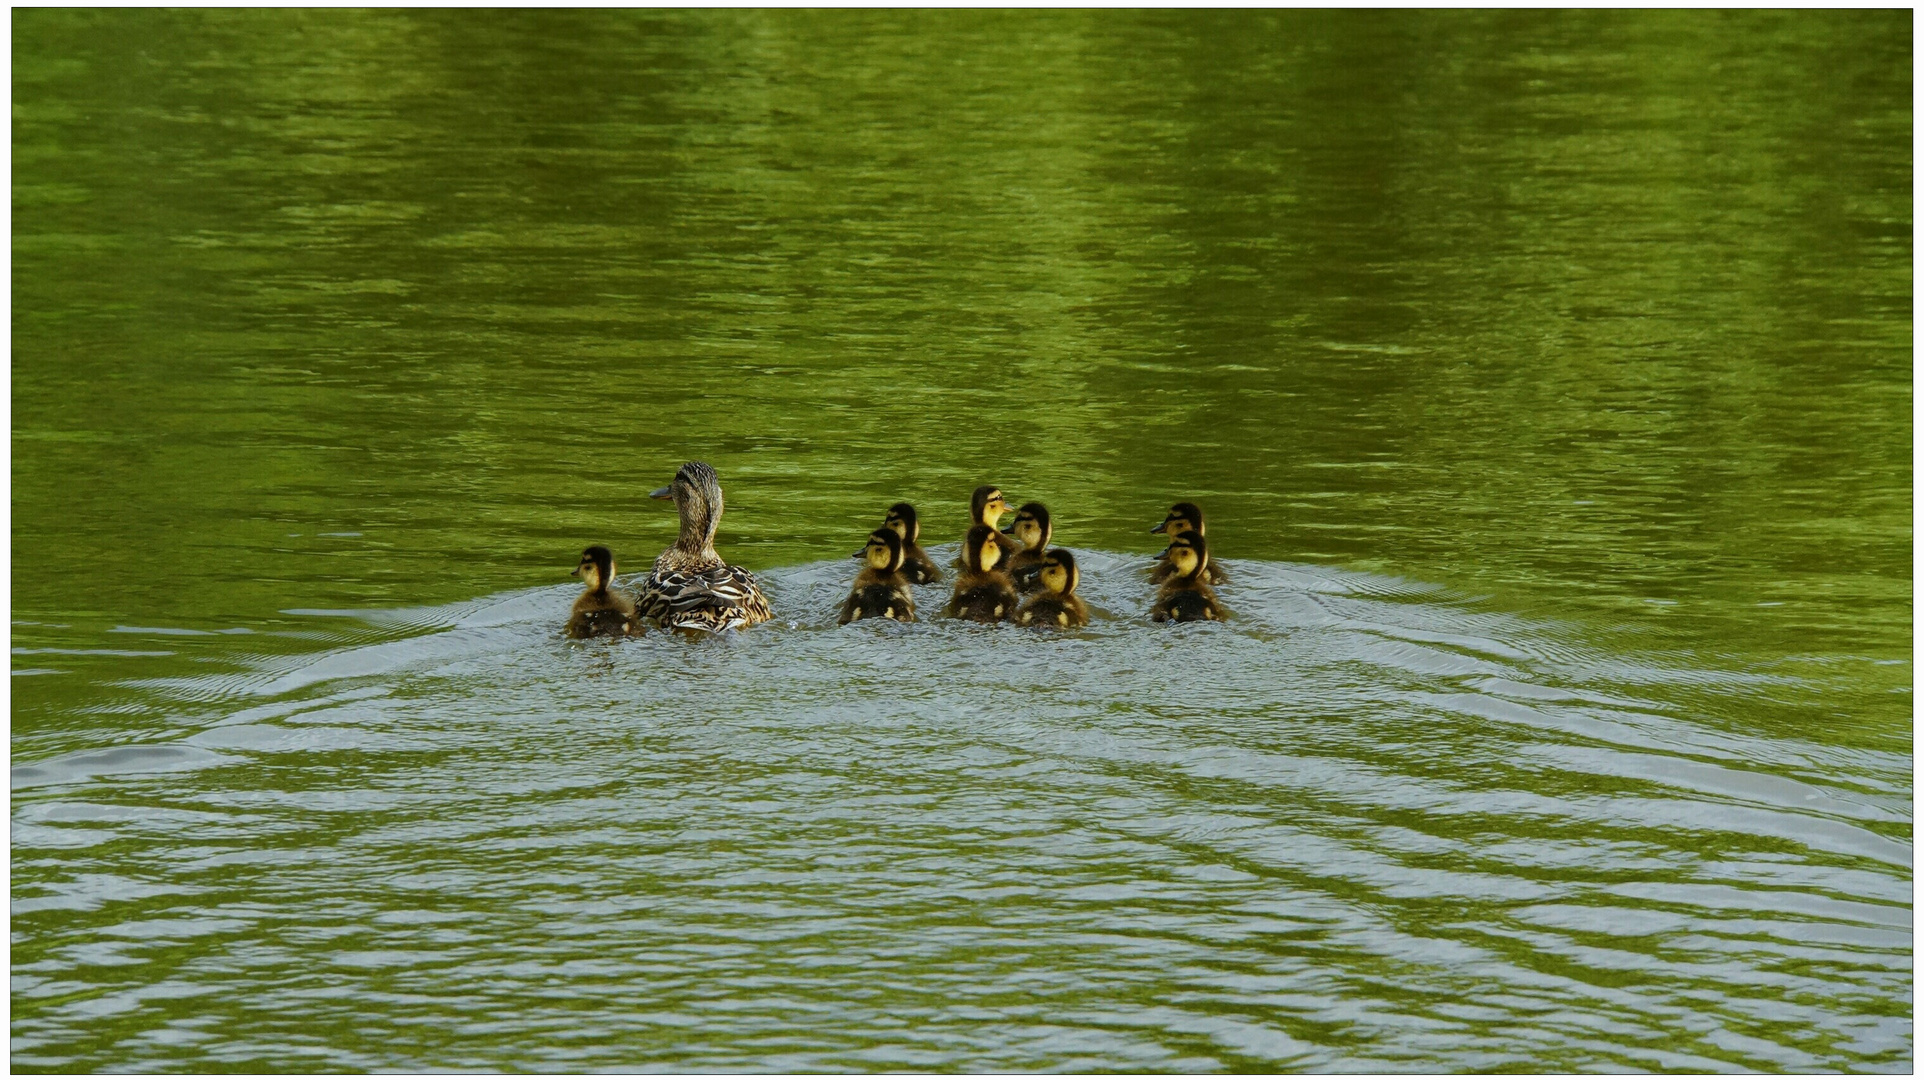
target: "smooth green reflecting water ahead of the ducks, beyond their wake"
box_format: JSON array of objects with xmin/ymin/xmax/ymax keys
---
[{"xmin": 12, "ymin": 10, "xmax": 1912, "ymax": 1070}]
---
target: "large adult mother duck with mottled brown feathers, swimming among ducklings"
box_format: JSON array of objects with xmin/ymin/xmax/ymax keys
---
[{"xmin": 637, "ymin": 462, "xmax": 773, "ymax": 633}]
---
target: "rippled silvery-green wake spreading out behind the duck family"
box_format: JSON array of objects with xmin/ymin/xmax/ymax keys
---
[{"xmin": 13, "ymin": 551, "xmax": 1911, "ymax": 1070}]
